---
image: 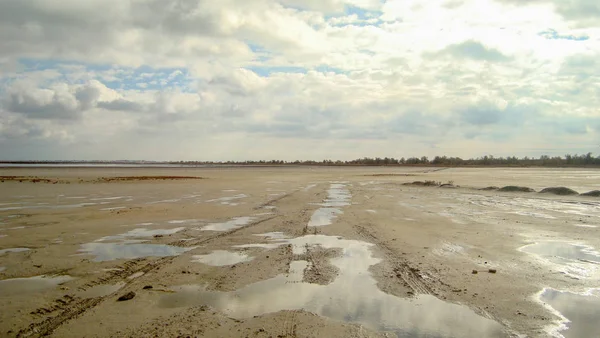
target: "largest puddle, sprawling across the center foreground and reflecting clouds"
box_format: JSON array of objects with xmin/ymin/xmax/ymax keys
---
[{"xmin": 159, "ymin": 235, "xmax": 505, "ymax": 337}]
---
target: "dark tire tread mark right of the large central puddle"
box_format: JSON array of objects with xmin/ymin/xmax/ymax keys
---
[{"xmin": 354, "ymin": 225, "xmax": 433, "ymax": 294}]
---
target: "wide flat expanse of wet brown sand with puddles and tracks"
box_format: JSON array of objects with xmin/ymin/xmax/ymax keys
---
[{"xmin": 0, "ymin": 167, "xmax": 600, "ymax": 337}]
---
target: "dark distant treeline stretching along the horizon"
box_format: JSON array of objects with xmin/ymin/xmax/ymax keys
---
[{"xmin": 0, "ymin": 153, "xmax": 600, "ymax": 167}]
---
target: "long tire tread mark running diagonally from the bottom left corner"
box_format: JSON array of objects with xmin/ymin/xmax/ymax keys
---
[{"xmin": 17, "ymin": 216, "xmax": 279, "ymax": 338}]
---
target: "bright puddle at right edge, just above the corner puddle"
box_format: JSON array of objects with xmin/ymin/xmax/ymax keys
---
[{"xmin": 519, "ymin": 242, "xmax": 600, "ymax": 279}]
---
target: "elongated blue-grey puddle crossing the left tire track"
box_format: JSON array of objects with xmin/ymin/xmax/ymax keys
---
[{"xmin": 79, "ymin": 243, "xmax": 194, "ymax": 262}]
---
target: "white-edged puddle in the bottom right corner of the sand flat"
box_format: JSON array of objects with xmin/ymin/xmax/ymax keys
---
[{"xmin": 539, "ymin": 289, "xmax": 600, "ymax": 338}]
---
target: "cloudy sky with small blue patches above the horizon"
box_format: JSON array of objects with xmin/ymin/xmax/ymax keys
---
[{"xmin": 0, "ymin": 0, "xmax": 600, "ymax": 161}]
